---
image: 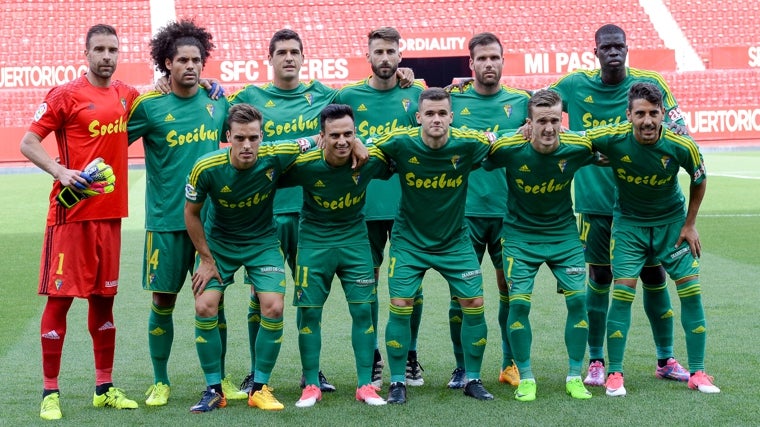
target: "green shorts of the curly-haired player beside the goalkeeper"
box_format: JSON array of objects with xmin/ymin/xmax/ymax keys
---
[{"xmin": 142, "ymin": 230, "xmax": 195, "ymax": 294}]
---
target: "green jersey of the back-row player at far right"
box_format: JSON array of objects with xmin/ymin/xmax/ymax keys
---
[{"xmin": 549, "ymin": 68, "xmax": 684, "ymax": 215}]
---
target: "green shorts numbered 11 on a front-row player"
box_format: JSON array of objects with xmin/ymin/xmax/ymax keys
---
[{"xmin": 293, "ymin": 243, "xmax": 377, "ymax": 307}]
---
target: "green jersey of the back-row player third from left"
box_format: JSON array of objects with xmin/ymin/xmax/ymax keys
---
[{"xmin": 230, "ymin": 80, "xmax": 337, "ymax": 214}]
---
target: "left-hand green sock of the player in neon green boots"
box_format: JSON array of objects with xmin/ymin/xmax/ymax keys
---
[{"xmin": 507, "ymin": 294, "xmax": 534, "ymax": 378}]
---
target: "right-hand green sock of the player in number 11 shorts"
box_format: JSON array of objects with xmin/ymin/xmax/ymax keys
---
[{"xmin": 348, "ymin": 303, "xmax": 377, "ymax": 387}]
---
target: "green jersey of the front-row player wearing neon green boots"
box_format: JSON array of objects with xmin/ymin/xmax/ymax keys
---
[{"xmin": 483, "ymin": 132, "xmax": 596, "ymax": 242}]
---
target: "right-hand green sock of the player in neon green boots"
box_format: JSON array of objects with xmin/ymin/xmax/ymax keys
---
[{"xmin": 564, "ymin": 291, "xmax": 588, "ymax": 377}]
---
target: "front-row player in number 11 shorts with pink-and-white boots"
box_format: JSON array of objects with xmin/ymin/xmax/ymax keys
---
[{"xmin": 280, "ymin": 104, "xmax": 391, "ymax": 408}]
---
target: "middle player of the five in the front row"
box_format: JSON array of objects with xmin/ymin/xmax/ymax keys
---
[{"xmin": 377, "ymin": 88, "xmax": 493, "ymax": 403}]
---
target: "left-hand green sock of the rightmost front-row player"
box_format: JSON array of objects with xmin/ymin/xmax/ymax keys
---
[{"xmin": 607, "ymin": 285, "xmax": 636, "ymax": 372}]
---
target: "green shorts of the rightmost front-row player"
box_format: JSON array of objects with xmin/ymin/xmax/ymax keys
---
[{"xmin": 611, "ymin": 222, "xmax": 699, "ymax": 280}]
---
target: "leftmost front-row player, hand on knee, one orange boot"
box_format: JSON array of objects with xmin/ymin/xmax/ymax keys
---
[{"xmin": 184, "ymin": 104, "xmax": 308, "ymax": 413}]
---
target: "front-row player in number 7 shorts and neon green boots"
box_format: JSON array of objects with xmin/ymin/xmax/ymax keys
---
[{"xmin": 483, "ymin": 89, "xmax": 593, "ymax": 402}]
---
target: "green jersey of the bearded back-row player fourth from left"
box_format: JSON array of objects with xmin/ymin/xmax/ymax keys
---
[{"xmin": 335, "ymin": 79, "xmax": 425, "ymax": 221}]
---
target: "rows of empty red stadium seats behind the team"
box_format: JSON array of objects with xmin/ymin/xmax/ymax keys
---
[{"xmin": 0, "ymin": 0, "xmax": 760, "ymax": 161}]
